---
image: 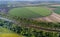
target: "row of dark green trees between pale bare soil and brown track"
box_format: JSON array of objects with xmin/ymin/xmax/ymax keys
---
[{"xmin": 10, "ymin": 16, "xmax": 60, "ymax": 29}]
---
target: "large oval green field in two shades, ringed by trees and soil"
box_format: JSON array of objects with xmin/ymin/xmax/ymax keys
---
[{"xmin": 9, "ymin": 7, "xmax": 51, "ymax": 18}]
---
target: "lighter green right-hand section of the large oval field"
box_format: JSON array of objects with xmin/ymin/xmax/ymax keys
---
[{"xmin": 26, "ymin": 7, "xmax": 51, "ymax": 16}]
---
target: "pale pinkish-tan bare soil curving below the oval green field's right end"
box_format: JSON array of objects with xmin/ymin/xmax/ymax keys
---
[{"xmin": 34, "ymin": 12, "xmax": 60, "ymax": 22}]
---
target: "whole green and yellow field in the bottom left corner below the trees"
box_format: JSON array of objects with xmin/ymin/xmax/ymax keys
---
[{"xmin": 0, "ymin": 27, "xmax": 23, "ymax": 37}]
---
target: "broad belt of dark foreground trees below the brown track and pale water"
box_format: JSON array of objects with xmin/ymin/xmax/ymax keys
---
[{"xmin": 0, "ymin": 20, "xmax": 60, "ymax": 37}]
